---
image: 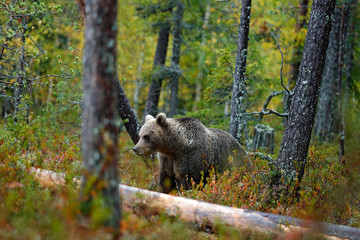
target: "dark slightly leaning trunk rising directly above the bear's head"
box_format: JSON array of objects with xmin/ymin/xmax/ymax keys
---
[{"xmin": 143, "ymin": 21, "xmax": 170, "ymax": 120}]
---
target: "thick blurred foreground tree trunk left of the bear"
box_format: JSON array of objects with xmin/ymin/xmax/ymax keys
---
[{"xmin": 81, "ymin": 0, "xmax": 121, "ymax": 233}]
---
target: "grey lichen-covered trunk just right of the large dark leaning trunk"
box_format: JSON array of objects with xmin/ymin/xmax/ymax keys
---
[{"xmin": 314, "ymin": 3, "xmax": 342, "ymax": 142}]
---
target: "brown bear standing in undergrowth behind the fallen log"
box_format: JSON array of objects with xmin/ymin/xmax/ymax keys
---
[{"xmin": 133, "ymin": 113, "xmax": 251, "ymax": 193}]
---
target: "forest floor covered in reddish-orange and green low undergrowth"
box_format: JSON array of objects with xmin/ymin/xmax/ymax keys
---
[{"xmin": 0, "ymin": 117, "xmax": 360, "ymax": 239}]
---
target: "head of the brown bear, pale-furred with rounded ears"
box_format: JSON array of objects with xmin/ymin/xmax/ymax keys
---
[{"xmin": 133, "ymin": 113, "xmax": 167, "ymax": 156}]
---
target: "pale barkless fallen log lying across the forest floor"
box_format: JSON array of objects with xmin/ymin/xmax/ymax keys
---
[{"xmin": 30, "ymin": 168, "xmax": 360, "ymax": 239}]
